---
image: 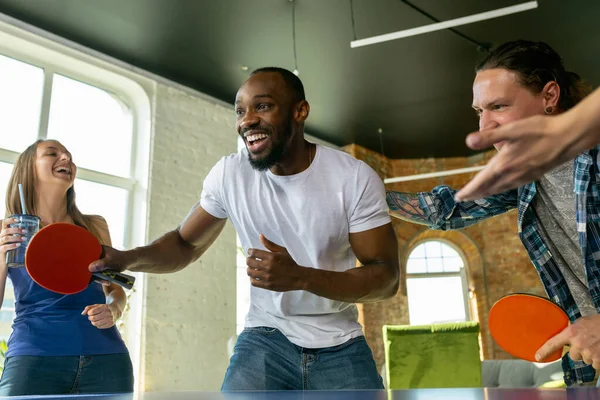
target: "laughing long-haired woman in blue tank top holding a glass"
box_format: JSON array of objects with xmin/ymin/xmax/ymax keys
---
[{"xmin": 0, "ymin": 140, "xmax": 133, "ymax": 396}]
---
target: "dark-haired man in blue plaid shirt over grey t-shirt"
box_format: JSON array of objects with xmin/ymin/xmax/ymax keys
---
[{"xmin": 387, "ymin": 40, "xmax": 600, "ymax": 385}]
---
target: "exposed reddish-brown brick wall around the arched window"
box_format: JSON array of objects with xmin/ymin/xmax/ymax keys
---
[{"xmin": 344, "ymin": 145, "xmax": 545, "ymax": 368}]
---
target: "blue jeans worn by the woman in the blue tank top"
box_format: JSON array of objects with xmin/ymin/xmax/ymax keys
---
[{"xmin": 0, "ymin": 353, "xmax": 133, "ymax": 396}]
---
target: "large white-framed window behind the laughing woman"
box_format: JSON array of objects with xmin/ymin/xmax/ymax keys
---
[{"xmin": 0, "ymin": 29, "xmax": 150, "ymax": 360}]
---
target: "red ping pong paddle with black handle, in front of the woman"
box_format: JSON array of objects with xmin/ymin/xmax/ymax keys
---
[{"xmin": 25, "ymin": 223, "xmax": 135, "ymax": 294}]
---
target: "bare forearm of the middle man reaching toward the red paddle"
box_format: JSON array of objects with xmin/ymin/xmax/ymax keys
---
[{"xmin": 126, "ymin": 230, "xmax": 202, "ymax": 274}]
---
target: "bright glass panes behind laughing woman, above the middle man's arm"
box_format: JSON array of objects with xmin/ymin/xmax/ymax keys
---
[{"xmin": 0, "ymin": 55, "xmax": 133, "ymax": 248}]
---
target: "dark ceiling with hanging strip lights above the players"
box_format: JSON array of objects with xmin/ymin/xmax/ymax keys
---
[{"xmin": 0, "ymin": 0, "xmax": 600, "ymax": 158}]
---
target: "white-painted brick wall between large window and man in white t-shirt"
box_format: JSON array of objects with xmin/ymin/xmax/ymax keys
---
[{"xmin": 143, "ymin": 84, "xmax": 237, "ymax": 391}]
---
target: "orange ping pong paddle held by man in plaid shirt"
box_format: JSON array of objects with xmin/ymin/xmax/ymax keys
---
[{"xmin": 488, "ymin": 293, "xmax": 569, "ymax": 362}]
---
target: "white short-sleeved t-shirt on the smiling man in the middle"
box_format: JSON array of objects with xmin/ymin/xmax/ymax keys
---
[{"xmin": 200, "ymin": 145, "xmax": 391, "ymax": 348}]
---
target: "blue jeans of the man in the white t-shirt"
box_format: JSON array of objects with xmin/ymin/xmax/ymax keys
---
[{"xmin": 221, "ymin": 327, "xmax": 383, "ymax": 391}]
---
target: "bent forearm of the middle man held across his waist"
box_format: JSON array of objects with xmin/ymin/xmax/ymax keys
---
[{"xmin": 302, "ymin": 263, "xmax": 399, "ymax": 303}]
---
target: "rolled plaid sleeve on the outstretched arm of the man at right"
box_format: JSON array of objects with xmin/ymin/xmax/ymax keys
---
[{"xmin": 419, "ymin": 186, "xmax": 518, "ymax": 230}]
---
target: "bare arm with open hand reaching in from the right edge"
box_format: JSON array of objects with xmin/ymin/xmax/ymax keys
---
[{"xmin": 456, "ymin": 89, "xmax": 600, "ymax": 201}]
